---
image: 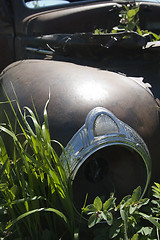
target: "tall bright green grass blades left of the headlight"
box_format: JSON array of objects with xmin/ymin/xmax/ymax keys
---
[{"xmin": 0, "ymin": 88, "xmax": 75, "ymax": 240}]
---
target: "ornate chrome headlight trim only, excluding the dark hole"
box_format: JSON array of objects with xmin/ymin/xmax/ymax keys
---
[{"xmin": 61, "ymin": 107, "xmax": 151, "ymax": 195}]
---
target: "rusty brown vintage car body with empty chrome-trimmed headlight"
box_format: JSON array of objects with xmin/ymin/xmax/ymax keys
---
[{"xmin": 0, "ymin": 0, "xmax": 160, "ymax": 206}]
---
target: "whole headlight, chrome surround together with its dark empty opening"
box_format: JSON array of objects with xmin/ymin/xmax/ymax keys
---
[{"xmin": 61, "ymin": 107, "xmax": 151, "ymax": 207}]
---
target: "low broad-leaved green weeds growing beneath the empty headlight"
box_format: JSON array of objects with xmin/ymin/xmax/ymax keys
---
[{"xmin": 82, "ymin": 183, "xmax": 160, "ymax": 240}]
